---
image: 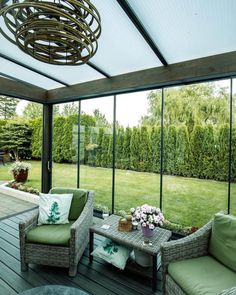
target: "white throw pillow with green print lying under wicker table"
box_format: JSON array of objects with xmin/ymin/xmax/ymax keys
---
[{"xmin": 92, "ymin": 239, "xmax": 132, "ymax": 269}]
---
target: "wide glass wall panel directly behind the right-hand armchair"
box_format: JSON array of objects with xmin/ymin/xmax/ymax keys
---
[{"xmin": 163, "ymin": 80, "xmax": 230, "ymax": 226}]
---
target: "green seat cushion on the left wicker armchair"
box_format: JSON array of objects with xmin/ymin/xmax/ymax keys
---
[{"xmin": 26, "ymin": 221, "xmax": 73, "ymax": 246}]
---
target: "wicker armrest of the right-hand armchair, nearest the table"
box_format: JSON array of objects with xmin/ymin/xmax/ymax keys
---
[{"xmin": 161, "ymin": 221, "xmax": 212, "ymax": 273}]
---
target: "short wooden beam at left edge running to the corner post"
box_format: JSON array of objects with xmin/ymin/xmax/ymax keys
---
[{"xmin": 0, "ymin": 77, "xmax": 46, "ymax": 103}]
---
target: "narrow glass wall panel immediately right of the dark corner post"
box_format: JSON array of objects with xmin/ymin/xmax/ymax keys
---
[{"xmin": 52, "ymin": 102, "xmax": 79, "ymax": 188}]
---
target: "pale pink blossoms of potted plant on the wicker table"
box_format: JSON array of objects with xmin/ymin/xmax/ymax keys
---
[{"xmin": 130, "ymin": 204, "xmax": 164, "ymax": 229}]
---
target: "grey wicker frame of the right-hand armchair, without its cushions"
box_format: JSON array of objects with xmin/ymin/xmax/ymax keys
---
[{"xmin": 161, "ymin": 221, "xmax": 236, "ymax": 295}]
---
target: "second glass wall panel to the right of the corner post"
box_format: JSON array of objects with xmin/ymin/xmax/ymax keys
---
[{"xmin": 79, "ymin": 97, "xmax": 114, "ymax": 211}]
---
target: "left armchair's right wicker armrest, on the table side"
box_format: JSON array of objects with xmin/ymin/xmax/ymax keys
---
[{"xmin": 70, "ymin": 191, "xmax": 94, "ymax": 256}]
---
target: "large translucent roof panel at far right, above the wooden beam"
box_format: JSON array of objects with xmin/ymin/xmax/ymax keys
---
[{"xmin": 128, "ymin": 0, "xmax": 236, "ymax": 63}]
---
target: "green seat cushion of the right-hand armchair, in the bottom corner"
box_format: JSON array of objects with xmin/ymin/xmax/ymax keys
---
[{"xmin": 168, "ymin": 256, "xmax": 236, "ymax": 295}]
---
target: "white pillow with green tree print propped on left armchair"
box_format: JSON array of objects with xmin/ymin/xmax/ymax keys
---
[{"xmin": 38, "ymin": 194, "xmax": 73, "ymax": 225}]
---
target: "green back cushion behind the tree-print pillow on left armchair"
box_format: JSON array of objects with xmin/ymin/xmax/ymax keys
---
[{"xmin": 50, "ymin": 187, "xmax": 87, "ymax": 220}]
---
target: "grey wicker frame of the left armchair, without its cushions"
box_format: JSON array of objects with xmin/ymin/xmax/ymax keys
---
[{"xmin": 19, "ymin": 191, "xmax": 94, "ymax": 276}]
